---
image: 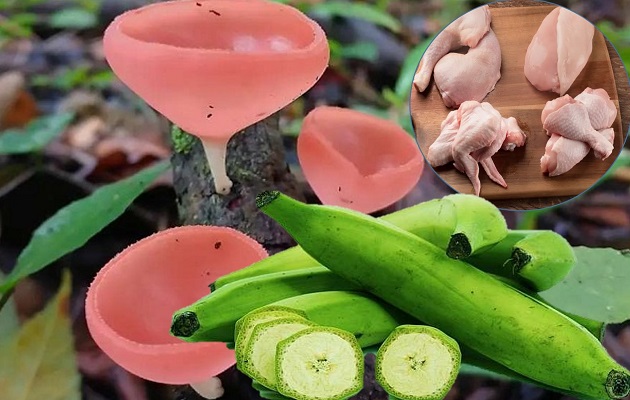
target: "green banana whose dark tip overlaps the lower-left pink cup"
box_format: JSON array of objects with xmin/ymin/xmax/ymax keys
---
[{"xmin": 171, "ymin": 267, "xmax": 359, "ymax": 342}]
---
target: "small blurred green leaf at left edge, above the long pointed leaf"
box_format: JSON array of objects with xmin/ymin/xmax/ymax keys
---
[{"xmin": 0, "ymin": 113, "xmax": 74, "ymax": 155}]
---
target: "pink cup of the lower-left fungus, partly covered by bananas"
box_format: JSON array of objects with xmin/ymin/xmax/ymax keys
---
[{"xmin": 85, "ymin": 226, "xmax": 267, "ymax": 387}]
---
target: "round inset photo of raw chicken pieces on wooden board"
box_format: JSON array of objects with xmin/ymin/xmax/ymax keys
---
[{"xmin": 410, "ymin": 0, "xmax": 630, "ymax": 209}]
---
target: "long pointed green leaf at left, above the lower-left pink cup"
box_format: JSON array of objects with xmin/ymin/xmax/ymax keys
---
[{"xmin": 0, "ymin": 161, "xmax": 169, "ymax": 293}]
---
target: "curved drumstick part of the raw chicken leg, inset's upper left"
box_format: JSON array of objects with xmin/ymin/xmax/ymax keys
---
[{"xmin": 413, "ymin": 6, "xmax": 491, "ymax": 92}]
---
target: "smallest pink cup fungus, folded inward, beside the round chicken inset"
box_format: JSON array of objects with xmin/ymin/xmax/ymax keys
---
[{"xmin": 297, "ymin": 107, "xmax": 424, "ymax": 213}]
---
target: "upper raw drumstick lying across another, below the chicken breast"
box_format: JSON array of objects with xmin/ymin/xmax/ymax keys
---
[{"xmin": 543, "ymin": 102, "xmax": 613, "ymax": 160}]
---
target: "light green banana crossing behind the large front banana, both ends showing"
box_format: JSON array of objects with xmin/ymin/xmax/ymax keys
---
[{"xmin": 210, "ymin": 194, "xmax": 507, "ymax": 291}]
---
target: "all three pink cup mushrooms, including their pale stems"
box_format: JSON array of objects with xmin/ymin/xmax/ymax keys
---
[{"xmin": 86, "ymin": 0, "xmax": 424, "ymax": 398}]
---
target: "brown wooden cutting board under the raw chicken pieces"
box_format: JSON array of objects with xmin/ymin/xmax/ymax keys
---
[{"xmin": 410, "ymin": 5, "xmax": 626, "ymax": 208}]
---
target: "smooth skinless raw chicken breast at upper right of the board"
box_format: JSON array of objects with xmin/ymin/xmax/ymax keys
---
[{"xmin": 525, "ymin": 7, "xmax": 595, "ymax": 95}]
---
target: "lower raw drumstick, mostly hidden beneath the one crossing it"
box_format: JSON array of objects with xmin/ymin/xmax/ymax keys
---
[{"xmin": 540, "ymin": 128, "xmax": 615, "ymax": 176}]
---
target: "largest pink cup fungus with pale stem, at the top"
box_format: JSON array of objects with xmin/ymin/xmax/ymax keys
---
[{"xmin": 103, "ymin": 0, "xmax": 329, "ymax": 194}]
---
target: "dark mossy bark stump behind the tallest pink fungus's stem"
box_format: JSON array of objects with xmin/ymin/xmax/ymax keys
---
[{"xmin": 172, "ymin": 116, "xmax": 303, "ymax": 253}]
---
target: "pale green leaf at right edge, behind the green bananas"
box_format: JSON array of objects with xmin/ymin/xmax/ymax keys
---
[{"xmin": 539, "ymin": 247, "xmax": 630, "ymax": 323}]
